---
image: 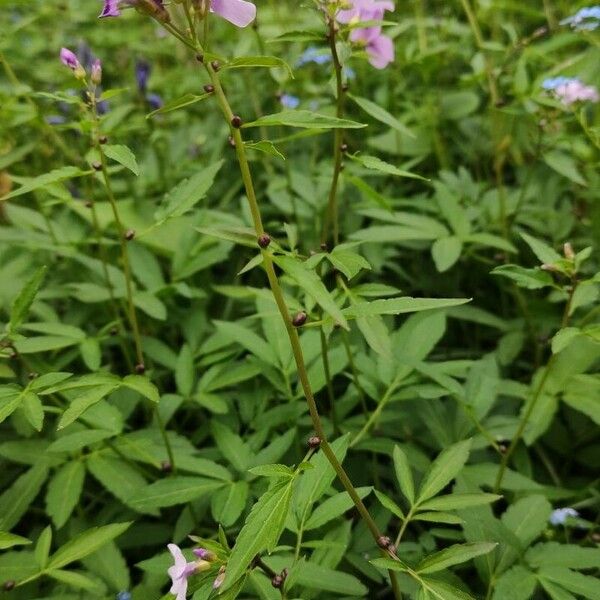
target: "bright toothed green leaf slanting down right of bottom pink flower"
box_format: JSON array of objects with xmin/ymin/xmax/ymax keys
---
[{"xmin": 221, "ymin": 478, "xmax": 295, "ymax": 592}]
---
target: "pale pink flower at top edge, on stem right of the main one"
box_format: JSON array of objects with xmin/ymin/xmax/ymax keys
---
[{"xmin": 336, "ymin": 0, "xmax": 394, "ymax": 69}]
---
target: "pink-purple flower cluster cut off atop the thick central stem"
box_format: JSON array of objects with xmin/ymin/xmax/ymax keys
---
[{"xmin": 100, "ymin": 0, "xmax": 256, "ymax": 27}]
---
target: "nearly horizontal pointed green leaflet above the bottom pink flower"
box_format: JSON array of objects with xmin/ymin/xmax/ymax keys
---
[{"xmin": 128, "ymin": 477, "xmax": 224, "ymax": 511}]
